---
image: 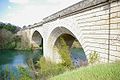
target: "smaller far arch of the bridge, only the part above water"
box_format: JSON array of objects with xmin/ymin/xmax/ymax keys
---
[{"xmin": 32, "ymin": 30, "xmax": 43, "ymax": 48}]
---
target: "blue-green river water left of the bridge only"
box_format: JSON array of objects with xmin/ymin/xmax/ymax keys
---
[{"xmin": 0, "ymin": 50, "xmax": 42, "ymax": 77}]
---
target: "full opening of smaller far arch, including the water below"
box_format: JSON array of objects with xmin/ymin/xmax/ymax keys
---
[{"xmin": 31, "ymin": 30, "xmax": 44, "ymax": 65}]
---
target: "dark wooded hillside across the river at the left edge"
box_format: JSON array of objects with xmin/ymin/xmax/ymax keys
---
[{"xmin": 0, "ymin": 22, "xmax": 21, "ymax": 49}]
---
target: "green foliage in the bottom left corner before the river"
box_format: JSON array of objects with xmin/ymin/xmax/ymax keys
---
[{"xmin": 0, "ymin": 65, "xmax": 33, "ymax": 80}]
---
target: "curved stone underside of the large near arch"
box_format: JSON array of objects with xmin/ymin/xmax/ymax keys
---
[{"xmin": 48, "ymin": 27, "xmax": 87, "ymax": 66}]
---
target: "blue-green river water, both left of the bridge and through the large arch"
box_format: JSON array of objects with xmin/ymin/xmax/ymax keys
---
[{"xmin": 0, "ymin": 48, "xmax": 87, "ymax": 79}]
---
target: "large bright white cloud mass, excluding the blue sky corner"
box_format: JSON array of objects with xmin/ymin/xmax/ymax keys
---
[{"xmin": 3, "ymin": 0, "xmax": 80, "ymax": 26}]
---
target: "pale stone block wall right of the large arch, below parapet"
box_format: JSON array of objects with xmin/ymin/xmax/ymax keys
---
[{"xmin": 74, "ymin": 1, "xmax": 120, "ymax": 62}]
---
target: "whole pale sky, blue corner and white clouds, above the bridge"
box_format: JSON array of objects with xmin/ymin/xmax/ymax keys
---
[{"xmin": 0, "ymin": 0, "xmax": 81, "ymax": 27}]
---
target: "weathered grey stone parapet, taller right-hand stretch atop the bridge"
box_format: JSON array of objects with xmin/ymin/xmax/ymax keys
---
[{"xmin": 43, "ymin": 0, "xmax": 116, "ymax": 23}]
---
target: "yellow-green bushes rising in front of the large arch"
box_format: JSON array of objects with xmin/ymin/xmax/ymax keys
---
[{"xmin": 34, "ymin": 37, "xmax": 73, "ymax": 79}]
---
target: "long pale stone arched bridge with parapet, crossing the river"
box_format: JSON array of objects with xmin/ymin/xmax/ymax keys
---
[{"xmin": 18, "ymin": 0, "xmax": 120, "ymax": 62}]
